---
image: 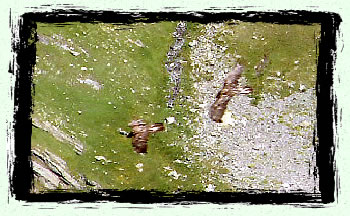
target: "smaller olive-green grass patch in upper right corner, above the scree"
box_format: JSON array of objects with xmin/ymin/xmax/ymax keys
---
[{"xmin": 216, "ymin": 22, "xmax": 320, "ymax": 104}]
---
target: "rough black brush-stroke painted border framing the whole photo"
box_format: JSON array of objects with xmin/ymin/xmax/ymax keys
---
[{"xmin": 8, "ymin": 9, "xmax": 342, "ymax": 206}]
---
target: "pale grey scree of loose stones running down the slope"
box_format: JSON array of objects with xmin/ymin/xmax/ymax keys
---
[{"xmin": 180, "ymin": 23, "xmax": 318, "ymax": 192}]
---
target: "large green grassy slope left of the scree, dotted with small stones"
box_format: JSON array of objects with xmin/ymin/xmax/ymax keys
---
[{"xmin": 32, "ymin": 22, "xmax": 201, "ymax": 191}]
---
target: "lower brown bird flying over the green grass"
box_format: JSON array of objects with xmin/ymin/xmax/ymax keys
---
[{"xmin": 127, "ymin": 119, "xmax": 164, "ymax": 153}]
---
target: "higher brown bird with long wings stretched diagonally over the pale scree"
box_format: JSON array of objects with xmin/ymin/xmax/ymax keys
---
[{"xmin": 209, "ymin": 64, "xmax": 252, "ymax": 123}]
